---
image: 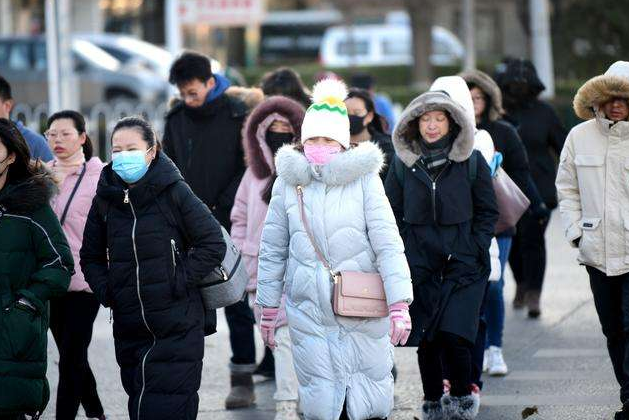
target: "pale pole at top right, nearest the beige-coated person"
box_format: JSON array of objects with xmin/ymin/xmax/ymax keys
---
[{"xmin": 529, "ymin": 0, "xmax": 555, "ymax": 98}]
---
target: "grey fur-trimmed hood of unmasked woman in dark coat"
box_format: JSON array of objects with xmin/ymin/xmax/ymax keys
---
[{"xmin": 392, "ymin": 92, "xmax": 474, "ymax": 168}]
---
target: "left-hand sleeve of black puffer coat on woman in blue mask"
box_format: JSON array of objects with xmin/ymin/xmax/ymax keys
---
[{"xmin": 79, "ymin": 196, "xmax": 112, "ymax": 307}]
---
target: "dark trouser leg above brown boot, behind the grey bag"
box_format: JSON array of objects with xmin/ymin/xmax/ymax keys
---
[{"xmin": 225, "ymin": 299, "xmax": 256, "ymax": 365}]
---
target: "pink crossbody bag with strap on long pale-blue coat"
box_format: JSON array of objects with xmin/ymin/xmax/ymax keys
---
[{"xmin": 297, "ymin": 185, "xmax": 389, "ymax": 318}]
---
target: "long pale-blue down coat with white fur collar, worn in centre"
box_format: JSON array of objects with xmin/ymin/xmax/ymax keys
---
[{"xmin": 257, "ymin": 142, "xmax": 413, "ymax": 420}]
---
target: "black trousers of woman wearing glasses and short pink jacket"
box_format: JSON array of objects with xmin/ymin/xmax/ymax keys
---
[{"xmin": 50, "ymin": 292, "xmax": 103, "ymax": 420}]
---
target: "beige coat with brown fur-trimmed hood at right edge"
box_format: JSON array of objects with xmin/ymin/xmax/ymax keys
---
[{"xmin": 556, "ymin": 62, "xmax": 629, "ymax": 276}]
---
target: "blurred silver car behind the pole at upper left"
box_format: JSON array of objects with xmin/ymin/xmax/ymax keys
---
[{"xmin": 0, "ymin": 36, "xmax": 169, "ymax": 108}]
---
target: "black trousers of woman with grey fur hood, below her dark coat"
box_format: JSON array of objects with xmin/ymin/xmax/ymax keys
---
[{"xmin": 417, "ymin": 331, "xmax": 474, "ymax": 401}]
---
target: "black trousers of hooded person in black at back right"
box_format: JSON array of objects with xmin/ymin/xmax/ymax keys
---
[{"xmin": 509, "ymin": 213, "xmax": 548, "ymax": 292}]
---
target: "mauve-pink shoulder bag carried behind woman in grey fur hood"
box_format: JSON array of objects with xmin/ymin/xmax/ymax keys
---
[{"xmin": 492, "ymin": 167, "xmax": 531, "ymax": 234}]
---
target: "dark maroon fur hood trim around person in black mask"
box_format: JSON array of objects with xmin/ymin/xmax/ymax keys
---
[{"xmin": 242, "ymin": 96, "xmax": 306, "ymax": 179}]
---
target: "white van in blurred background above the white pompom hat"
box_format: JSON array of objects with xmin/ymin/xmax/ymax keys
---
[{"xmin": 320, "ymin": 23, "xmax": 465, "ymax": 67}]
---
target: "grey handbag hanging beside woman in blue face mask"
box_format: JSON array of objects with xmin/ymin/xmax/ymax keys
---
[{"xmin": 197, "ymin": 226, "xmax": 249, "ymax": 310}]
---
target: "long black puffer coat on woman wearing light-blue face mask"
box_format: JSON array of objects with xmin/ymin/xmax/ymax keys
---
[{"xmin": 81, "ymin": 153, "xmax": 225, "ymax": 420}]
